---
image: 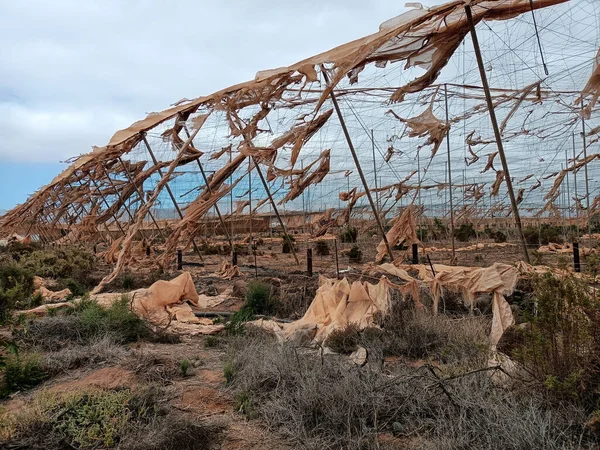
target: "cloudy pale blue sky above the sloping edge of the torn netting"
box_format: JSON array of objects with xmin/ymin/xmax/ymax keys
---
[{"xmin": 0, "ymin": 0, "xmax": 450, "ymax": 209}]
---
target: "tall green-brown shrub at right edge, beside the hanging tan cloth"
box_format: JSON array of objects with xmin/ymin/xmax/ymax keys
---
[{"xmin": 511, "ymin": 273, "xmax": 600, "ymax": 407}]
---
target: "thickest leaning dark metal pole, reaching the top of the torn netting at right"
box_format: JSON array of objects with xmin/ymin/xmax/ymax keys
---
[{"xmin": 465, "ymin": 5, "xmax": 529, "ymax": 264}]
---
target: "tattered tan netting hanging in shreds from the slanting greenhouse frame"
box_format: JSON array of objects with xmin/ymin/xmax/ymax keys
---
[{"xmin": 0, "ymin": 0, "xmax": 600, "ymax": 291}]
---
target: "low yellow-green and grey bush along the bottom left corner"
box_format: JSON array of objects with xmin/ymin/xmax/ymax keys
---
[{"xmin": 0, "ymin": 386, "xmax": 220, "ymax": 450}]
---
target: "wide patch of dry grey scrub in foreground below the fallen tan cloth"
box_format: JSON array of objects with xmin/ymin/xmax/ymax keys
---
[{"xmin": 230, "ymin": 337, "xmax": 597, "ymax": 450}]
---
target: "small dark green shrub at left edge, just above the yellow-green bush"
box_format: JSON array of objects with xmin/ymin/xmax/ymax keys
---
[{"xmin": 0, "ymin": 353, "xmax": 47, "ymax": 398}]
